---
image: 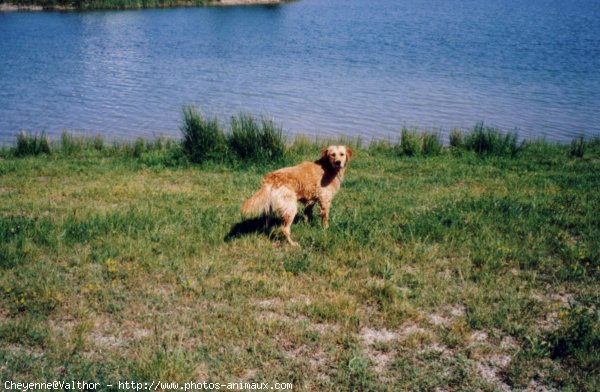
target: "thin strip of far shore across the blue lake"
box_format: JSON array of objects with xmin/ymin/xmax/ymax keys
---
[{"xmin": 0, "ymin": 0, "xmax": 293, "ymax": 12}]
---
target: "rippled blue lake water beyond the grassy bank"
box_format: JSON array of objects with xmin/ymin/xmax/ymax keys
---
[{"xmin": 0, "ymin": 0, "xmax": 600, "ymax": 144}]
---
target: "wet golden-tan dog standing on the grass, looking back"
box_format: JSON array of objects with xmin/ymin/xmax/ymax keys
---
[{"xmin": 242, "ymin": 145, "xmax": 352, "ymax": 247}]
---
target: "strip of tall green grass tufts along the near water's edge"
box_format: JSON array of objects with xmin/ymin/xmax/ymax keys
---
[{"xmin": 0, "ymin": 112, "xmax": 600, "ymax": 166}]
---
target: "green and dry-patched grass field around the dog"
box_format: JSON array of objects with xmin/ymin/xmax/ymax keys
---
[{"xmin": 0, "ymin": 125, "xmax": 600, "ymax": 391}]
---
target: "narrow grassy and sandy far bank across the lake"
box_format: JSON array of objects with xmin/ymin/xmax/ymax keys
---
[{"xmin": 0, "ymin": 0, "xmax": 293, "ymax": 12}]
